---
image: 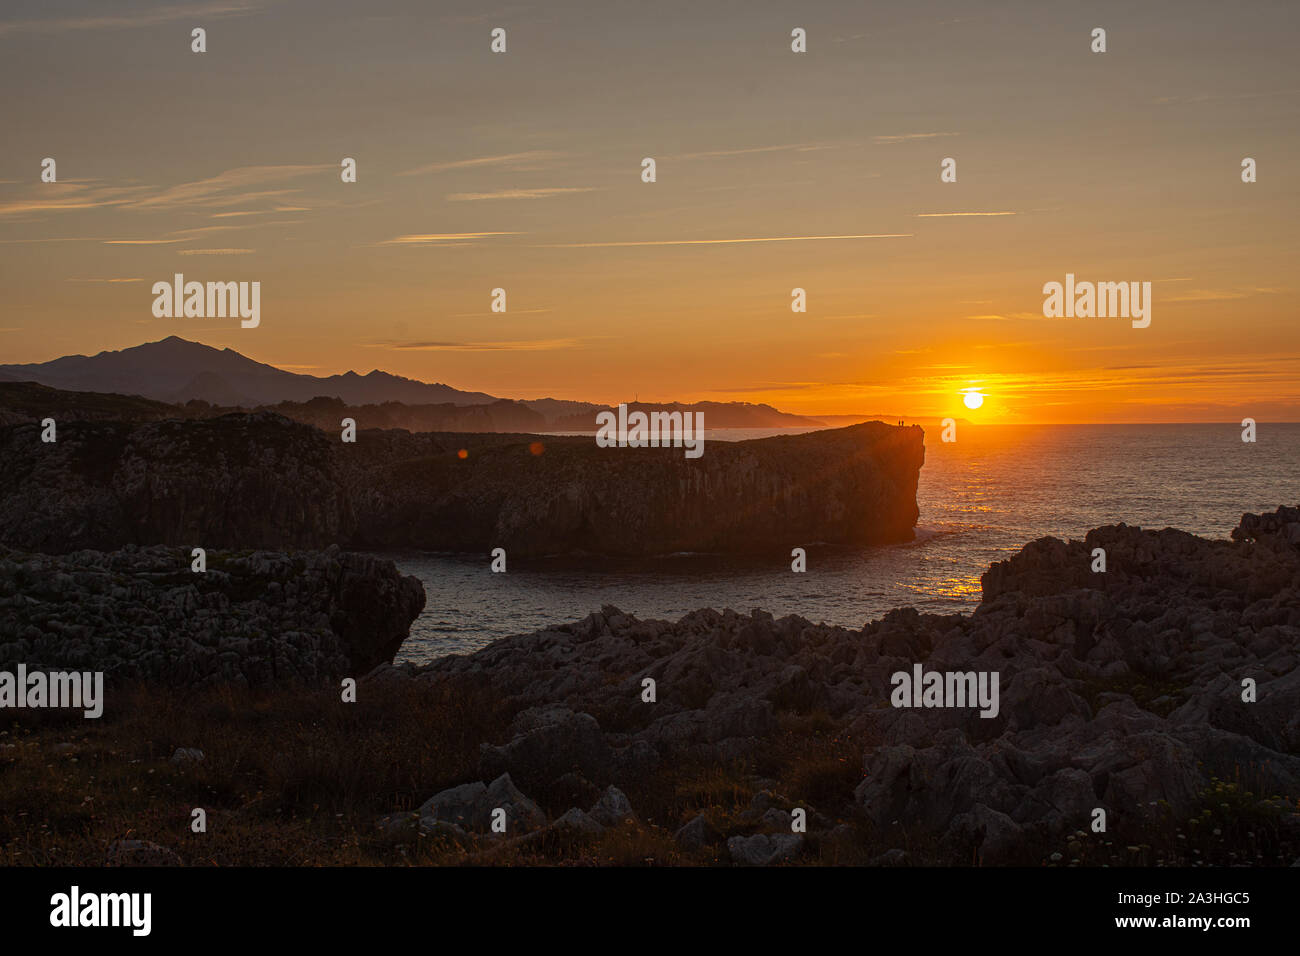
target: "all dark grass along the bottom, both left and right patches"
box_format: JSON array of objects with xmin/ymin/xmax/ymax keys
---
[{"xmin": 0, "ymin": 679, "xmax": 1300, "ymax": 866}]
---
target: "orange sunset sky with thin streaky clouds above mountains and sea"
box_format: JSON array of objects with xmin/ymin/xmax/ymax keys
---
[{"xmin": 0, "ymin": 0, "xmax": 1300, "ymax": 421}]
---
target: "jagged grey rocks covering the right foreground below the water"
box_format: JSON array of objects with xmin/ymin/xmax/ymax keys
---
[{"xmin": 369, "ymin": 509, "xmax": 1300, "ymax": 862}]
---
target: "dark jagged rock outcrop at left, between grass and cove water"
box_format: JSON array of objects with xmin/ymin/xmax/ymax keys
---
[{"xmin": 0, "ymin": 546, "xmax": 425, "ymax": 687}]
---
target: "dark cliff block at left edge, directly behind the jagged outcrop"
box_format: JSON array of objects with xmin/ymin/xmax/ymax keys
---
[{"xmin": 0, "ymin": 412, "xmax": 352, "ymax": 553}]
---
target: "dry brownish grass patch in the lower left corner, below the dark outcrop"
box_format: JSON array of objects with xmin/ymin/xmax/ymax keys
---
[{"xmin": 0, "ymin": 684, "xmax": 511, "ymax": 865}]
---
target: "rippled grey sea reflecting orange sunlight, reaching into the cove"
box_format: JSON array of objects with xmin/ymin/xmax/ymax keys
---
[{"xmin": 385, "ymin": 423, "xmax": 1300, "ymax": 662}]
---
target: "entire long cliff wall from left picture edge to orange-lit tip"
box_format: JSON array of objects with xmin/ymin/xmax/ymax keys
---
[{"xmin": 0, "ymin": 412, "xmax": 924, "ymax": 555}]
